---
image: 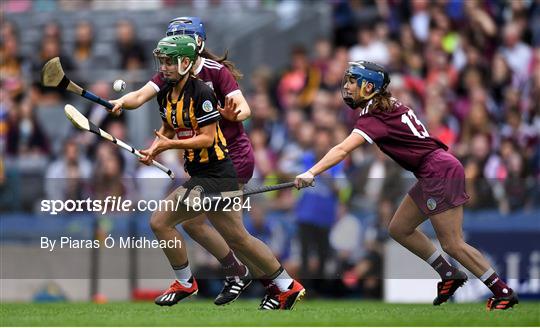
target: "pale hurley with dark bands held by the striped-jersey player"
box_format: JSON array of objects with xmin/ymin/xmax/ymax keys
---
[{"xmin": 64, "ymin": 104, "xmax": 174, "ymax": 179}]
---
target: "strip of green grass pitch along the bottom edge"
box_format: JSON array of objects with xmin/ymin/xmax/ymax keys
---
[{"xmin": 0, "ymin": 300, "xmax": 540, "ymax": 326}]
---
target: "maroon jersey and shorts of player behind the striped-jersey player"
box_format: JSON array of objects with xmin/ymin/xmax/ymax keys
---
[{"xmin": 150, "ymin": 58, "xmax": 254, "ymax": 183}]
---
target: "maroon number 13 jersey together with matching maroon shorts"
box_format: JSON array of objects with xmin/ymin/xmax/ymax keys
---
[{"xmin": 353, "ymin": 99, "xmax": 469, "ymax": 216}]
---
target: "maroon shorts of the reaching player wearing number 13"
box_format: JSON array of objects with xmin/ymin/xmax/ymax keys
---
[{"xmin": 409, "ymin": 149, "xmax": 469, "ymax": 216}]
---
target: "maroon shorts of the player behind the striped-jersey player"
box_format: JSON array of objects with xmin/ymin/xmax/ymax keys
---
[{"xmin": 227, "ymin": 133, "xmax": 255, "ymax": 184}]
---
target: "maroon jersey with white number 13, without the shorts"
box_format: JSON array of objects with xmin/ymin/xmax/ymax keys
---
[{"xmin": 353, "ymin": 100, "xmax": 448, "ymax": 173}]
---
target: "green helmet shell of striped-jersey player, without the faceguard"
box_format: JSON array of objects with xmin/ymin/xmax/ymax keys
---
[{"xmin": 154, "ymin": 35, "xmax": 198, "ymax": 75}]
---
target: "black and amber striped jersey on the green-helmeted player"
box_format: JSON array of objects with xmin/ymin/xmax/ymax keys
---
[{"xmin": 157, "ymin": 77, "xmax": 228, "ymax": 173}]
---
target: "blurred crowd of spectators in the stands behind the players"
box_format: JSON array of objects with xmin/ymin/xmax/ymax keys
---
[{"xmin": 0, "ymin": 0, "xmax": 540, "ymax": 296}]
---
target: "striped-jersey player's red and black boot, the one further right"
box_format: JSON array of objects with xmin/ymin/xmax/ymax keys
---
[{"xmin": 259, "ymin": 280, "xmax": 306, "ymax": 310}]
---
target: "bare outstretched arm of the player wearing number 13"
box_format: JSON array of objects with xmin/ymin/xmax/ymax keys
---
[{"xmin": 294, "ymin": 133, "xmax": 366, "ymax": 188}]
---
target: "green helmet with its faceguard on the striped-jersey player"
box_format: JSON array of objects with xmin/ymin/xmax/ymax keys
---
[{"xmin": 154, "ymin": 35, "xmax": 198, "ymax": 83}]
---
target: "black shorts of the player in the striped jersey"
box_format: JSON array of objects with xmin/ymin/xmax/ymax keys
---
[{"xmin": 182, "ymin": 157, "xmax": 238, "ymax": 194}]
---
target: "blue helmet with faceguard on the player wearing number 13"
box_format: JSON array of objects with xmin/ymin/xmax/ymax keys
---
[{"xmin": 341, "ymin": 61, "xmax": 390, "ymax": 109}]
